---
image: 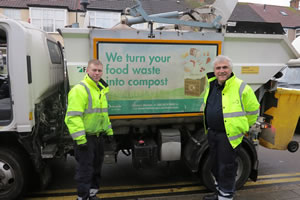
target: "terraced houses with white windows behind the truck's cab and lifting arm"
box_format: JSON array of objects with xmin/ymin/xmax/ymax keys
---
[{"xmin": 0, "ymin": 0, "xmax": 192, "ymax": 42}]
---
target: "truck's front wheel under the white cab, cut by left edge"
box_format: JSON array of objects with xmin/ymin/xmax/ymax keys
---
[{"xmin": 0, "ymin": 147, "xmax": 26, "ymax": 199}]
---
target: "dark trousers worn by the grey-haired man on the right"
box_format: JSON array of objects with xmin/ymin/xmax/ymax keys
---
[{"xmin": 207, "ymin": 129, "xmax": 239, "ymax": 198}]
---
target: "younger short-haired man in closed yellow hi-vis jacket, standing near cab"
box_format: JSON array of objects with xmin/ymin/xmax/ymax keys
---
[{"xmin": 65, "ymin": 60, "xmax": 113, "ymax": 200}]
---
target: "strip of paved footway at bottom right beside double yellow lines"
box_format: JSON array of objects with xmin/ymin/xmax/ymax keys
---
[{"xmin": 138, "ymin": 183, "xmax": 300, "ymax": 200}]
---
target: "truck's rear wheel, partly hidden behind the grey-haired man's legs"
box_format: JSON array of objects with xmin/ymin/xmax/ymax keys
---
[{"xmin": 200, "ymin": 147, "xmax": 251, "ymax": 191}]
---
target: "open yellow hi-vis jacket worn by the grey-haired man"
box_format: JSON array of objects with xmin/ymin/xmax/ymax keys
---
[{"xmin": 204, "ymin": 73, "xmax": 259, "ymax": 148}]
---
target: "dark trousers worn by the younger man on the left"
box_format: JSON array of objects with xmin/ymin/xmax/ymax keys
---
[{"xmin": 75, "ymin": 136, "xmax": 104, "ymax": 200}]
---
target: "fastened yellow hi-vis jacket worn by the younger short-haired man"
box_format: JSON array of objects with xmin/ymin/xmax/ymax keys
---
[{"xmin": 65, "ymin": 75, "xmax": 113, "ymax": 144}]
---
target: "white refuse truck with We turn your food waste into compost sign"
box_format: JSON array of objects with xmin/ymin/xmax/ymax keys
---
[{"xmin": 0, "ymin": 1, "xmax": 298, "ymax": 199}]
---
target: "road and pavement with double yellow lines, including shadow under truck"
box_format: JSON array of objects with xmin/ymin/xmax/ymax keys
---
[{"xmin": 25, "ymin": 134, "xmax": 300, "ymax": 200}]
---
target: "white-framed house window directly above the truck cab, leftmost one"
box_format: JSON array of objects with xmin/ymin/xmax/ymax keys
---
[{"xmin": 29, "ymin": 8, "xmax": 67, "ymax": 32}]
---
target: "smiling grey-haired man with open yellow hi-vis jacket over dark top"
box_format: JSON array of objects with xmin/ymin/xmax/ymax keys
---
[{"xmin": 203, "ymin": 55, "xmax": 259, "ymax": 200}]
